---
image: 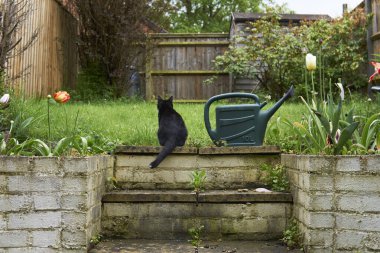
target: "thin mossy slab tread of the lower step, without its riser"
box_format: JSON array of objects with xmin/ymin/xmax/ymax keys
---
[{"xmin": 102, "ymin": 189, "xmax": 293, "ymax": 203}]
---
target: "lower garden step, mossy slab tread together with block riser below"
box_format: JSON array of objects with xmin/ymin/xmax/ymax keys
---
[{"xmin": 102, "ymin": 190, "xmax": 292, "ymax": 240}]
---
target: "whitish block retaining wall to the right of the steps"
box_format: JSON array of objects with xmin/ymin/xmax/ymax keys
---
[{"xmin": 281, "ymin": 154, "xmax": 380, "ymax": 253}]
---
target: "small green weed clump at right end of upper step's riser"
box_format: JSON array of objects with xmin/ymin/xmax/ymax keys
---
[{"xmin": 261, "ymin": 164, "xmax": 289, "ymax": 192}]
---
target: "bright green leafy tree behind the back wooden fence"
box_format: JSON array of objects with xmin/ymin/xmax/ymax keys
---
[{"xmin": 169, "ymin": 0, "xmax": 262, "ymax": 32}]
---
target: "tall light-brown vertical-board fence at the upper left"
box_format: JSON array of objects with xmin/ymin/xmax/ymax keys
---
[{"xmin": 7, "ymin": 0, "xmax": 77, "ymax": 97}]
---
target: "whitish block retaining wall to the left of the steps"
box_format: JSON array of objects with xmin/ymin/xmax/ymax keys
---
[{"xmin": 0, "ymin": 156, "xmax": 113, "ymax": 253}]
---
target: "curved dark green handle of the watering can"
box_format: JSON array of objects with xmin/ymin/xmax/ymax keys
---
[{"xmin": 203, "ymin": 92, "xmax": 265, "ymax": 145}]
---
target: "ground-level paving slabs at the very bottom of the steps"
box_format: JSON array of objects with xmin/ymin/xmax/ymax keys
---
[{"xmin": 89, "ymin": 239, "xmax": 302, "ymax": 253}]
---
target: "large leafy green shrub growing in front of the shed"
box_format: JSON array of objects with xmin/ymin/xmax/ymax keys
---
[{"xmin": 211, "ymin": 8, "xmax": 367, "ymax": 98}]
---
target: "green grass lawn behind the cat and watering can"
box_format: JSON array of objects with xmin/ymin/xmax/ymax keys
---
[{"xmin": 9, "ymin": 96, "xmax": 378, "ymax": 147}]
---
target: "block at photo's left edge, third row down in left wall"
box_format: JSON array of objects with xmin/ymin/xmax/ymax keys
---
[{"xmin": 0, "ymin": 195, "xmax": 32, "ymax": 213}]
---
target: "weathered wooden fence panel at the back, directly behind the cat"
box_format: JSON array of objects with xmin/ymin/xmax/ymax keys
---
[{"xmin": 145, "ymin": 34, "xmax": 231, "ymax": 100}]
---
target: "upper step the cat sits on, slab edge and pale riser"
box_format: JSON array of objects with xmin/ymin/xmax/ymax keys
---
[{"xmin": 114, "ymin": 146, "xmax": 280, "ymax": 189}]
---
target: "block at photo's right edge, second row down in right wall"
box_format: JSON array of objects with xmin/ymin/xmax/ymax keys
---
[{"xmin": 335, "ymin": 175, "xmax": 380, "ymax": 193}]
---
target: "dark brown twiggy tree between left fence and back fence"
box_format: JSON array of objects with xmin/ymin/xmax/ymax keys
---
[{"xmin": 73, "ymin": 0, "xmax": 171, "ymax": 96}]
